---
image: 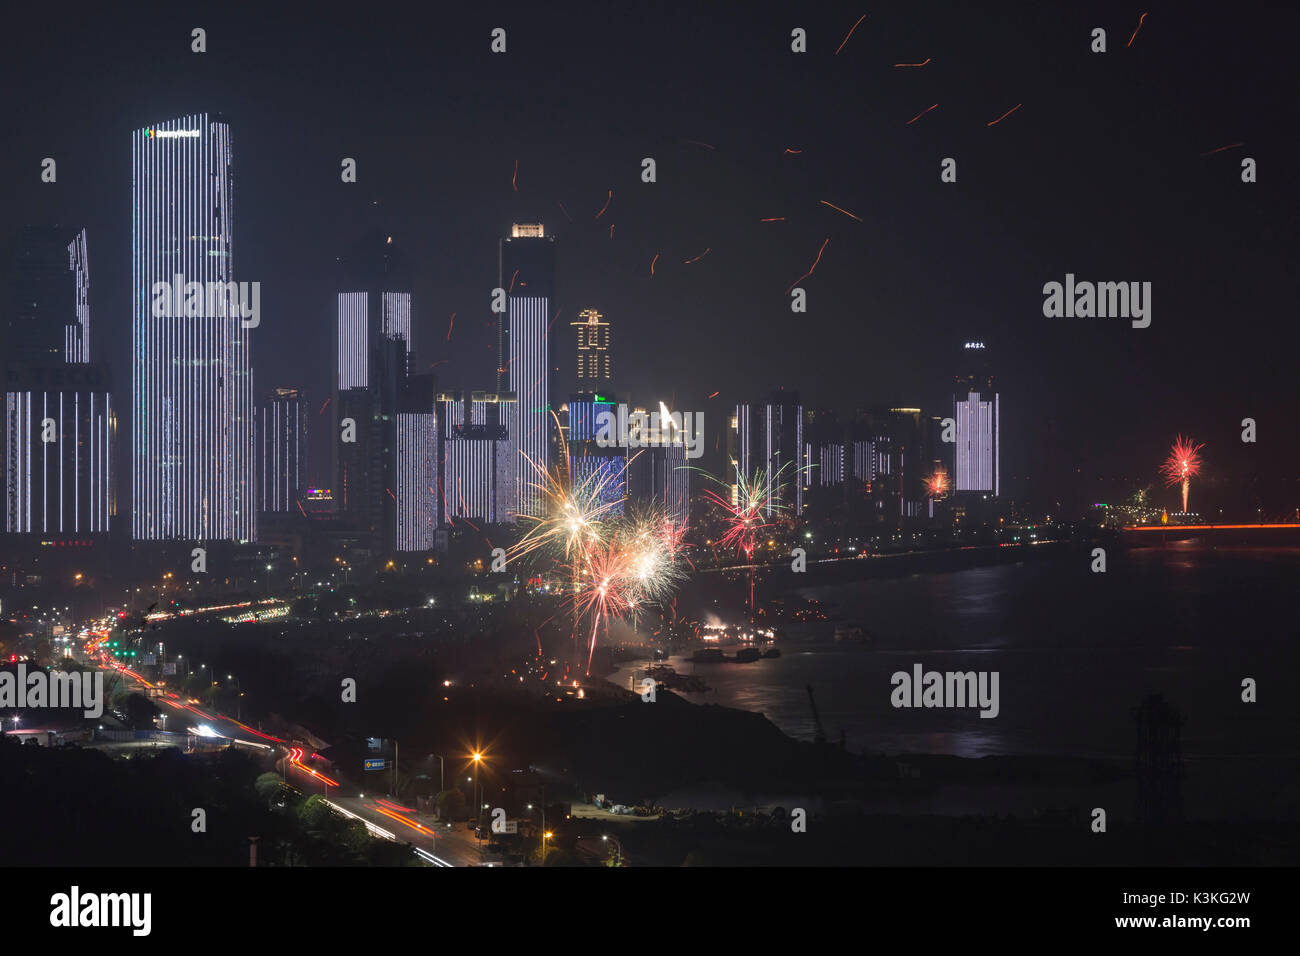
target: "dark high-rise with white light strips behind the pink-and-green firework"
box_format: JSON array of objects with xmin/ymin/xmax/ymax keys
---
[{"xmin": 729, "ymin": 392, "xmax": 805, "ymax": 515}]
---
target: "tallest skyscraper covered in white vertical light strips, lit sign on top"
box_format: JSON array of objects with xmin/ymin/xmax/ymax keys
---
[{"xmin": 131, "ymin": 113, "xmax": 256, "ymax": 541}]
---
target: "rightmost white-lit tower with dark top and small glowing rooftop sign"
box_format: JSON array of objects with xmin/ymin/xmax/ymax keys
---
[{"xmin": 953, "ymin": 342, "xmax": 1002, "ymax": 497}]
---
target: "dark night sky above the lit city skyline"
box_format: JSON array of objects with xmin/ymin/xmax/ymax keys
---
[{"xmin": 0, "ymin": 3, "xmax": 1300, "ymax": 504}]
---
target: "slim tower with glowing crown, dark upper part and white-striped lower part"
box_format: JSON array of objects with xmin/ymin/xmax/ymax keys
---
[{"xmin": 497, "ymin": 224, "xmax": 558, "ymax": 515}]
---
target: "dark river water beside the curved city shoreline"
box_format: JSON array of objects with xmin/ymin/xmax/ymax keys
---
[{"xmin": 611, "ymin": 545, "xmax": 1300, "ymax": 765}]
